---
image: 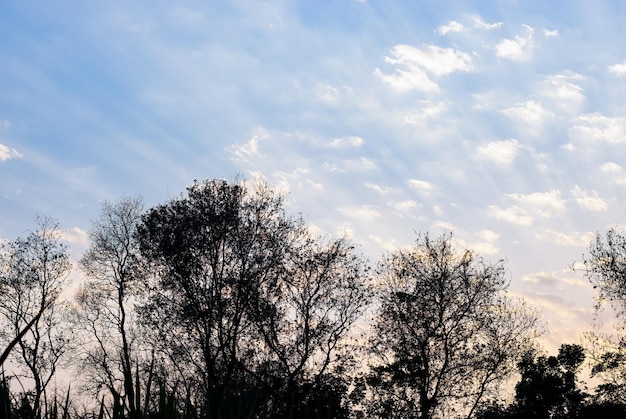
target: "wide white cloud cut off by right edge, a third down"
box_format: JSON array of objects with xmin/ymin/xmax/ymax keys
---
[{"xmin": 569, "ymin": 113, "xmax": 626, "ymax": 144}]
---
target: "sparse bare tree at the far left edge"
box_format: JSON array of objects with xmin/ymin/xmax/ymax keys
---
[{"xmin": 0, "ymin": 217, "xmax": 71, "ymax": 412}]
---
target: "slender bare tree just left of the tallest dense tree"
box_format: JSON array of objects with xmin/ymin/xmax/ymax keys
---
[{"xmin": 76, "ymin": 198, "xmax": 143, "ymax": 418}]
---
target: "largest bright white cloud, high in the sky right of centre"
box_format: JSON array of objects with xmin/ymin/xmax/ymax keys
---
[{"xmin": 374, "ymin": 45, "xmax": 472, "ymax": 92}]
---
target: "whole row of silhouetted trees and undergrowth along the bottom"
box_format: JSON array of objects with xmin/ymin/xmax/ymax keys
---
[{"xmin": 0, "ymin": 179, "xmax": 626, "ymax": 419}]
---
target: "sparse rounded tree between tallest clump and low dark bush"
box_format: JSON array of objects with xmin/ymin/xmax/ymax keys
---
[{"xmin": 369, "ymin": 234, "xmax": 537, "ymax": 418}]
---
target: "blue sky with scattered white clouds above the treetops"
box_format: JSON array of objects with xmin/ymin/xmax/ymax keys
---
[{"xmin": 0, "ymin": 0, "xmax": 626, "ymax": 354}]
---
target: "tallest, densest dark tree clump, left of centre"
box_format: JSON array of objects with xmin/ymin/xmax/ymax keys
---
[{"xmin": 138, "ymin": 180, "xmax": 368, "ymax": 416}]
